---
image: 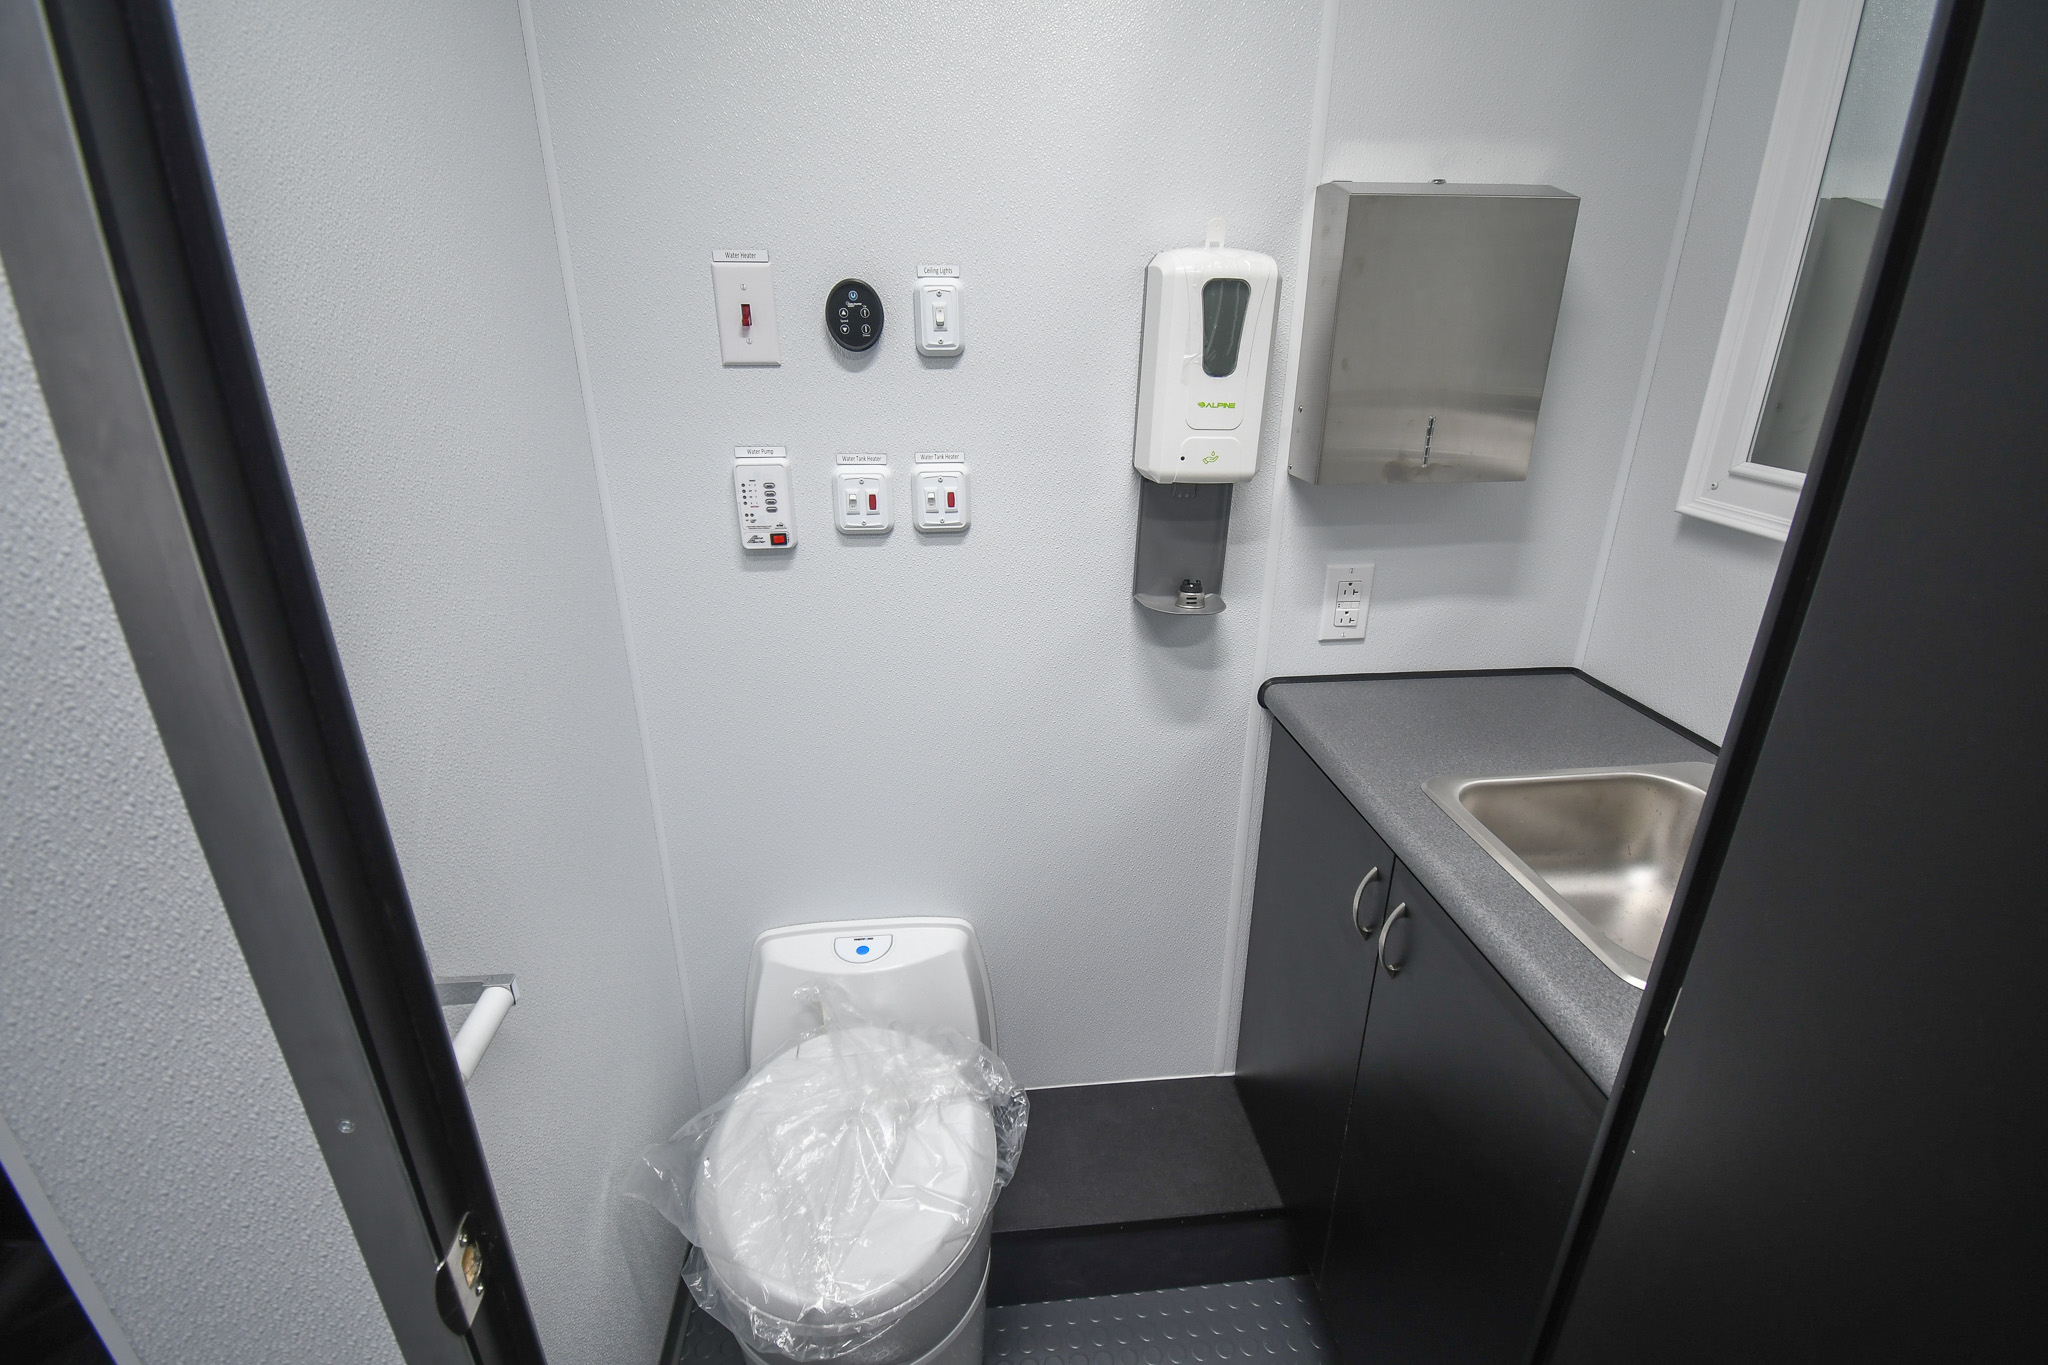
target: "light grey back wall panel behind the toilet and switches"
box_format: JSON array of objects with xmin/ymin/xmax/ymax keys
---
[{"xmin": 535, "ymin": 0, "xmax": 1321, "ymax": 1091}]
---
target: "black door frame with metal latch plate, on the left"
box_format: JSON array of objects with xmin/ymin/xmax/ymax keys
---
[{"xmin": 0, "ymin": 0, "xmax": 545, "ymax": 1365}]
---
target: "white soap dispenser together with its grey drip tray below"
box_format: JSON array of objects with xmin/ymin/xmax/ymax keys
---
[{"xmin": 1130, "ymin": 219, "xmax": 1280, "ymax": 616}]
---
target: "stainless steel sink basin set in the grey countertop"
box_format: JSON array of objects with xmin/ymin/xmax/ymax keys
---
[{"xmin": 1421, "ymin": 763, "xmax": 1714, "ymax": 988}]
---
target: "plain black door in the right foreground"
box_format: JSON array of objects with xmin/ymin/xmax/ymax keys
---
[{"xmin": 1542, "ymin": 0, "xmax": 2048, "ymax": 1365}]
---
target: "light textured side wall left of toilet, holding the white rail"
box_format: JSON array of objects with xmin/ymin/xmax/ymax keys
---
[{"xmin": 178, "ymin": 0, "xmax": 696, "ymax": 1365}]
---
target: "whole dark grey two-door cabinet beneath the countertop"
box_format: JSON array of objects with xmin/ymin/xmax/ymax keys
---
[{"xmin": 1237, "ymin": 724, "xmax": 1606, "ymax": 1365}]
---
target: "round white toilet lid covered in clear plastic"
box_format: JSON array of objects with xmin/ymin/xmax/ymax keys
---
[{"xmin": 696, "ymin": 1025, "xmax": 995, "ymax": 1324}]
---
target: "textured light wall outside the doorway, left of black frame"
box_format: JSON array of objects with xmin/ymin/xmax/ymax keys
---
[{"xmin": 0, "ymin": 261, "xmax": 399, "ymax": 1365}]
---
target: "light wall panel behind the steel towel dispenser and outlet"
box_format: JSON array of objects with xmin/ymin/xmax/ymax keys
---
[{"xmin": 1268, "ymin": 0, "xmax": 1767, "ymax": 675}]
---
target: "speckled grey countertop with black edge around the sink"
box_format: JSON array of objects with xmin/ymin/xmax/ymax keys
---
[{"xmin": 1266, "ymin": 673, "xmax": 1714, "ymax": 1091}]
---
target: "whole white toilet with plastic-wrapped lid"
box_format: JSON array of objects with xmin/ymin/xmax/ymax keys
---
[{"xmin": 700, "ymin": 917, "xmax": 997, "ymax": 1365}]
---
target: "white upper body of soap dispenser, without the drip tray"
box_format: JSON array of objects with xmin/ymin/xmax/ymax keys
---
[{"xmin": 1133, "ymin": 246, "xmax": 1280, "ymax": 483}]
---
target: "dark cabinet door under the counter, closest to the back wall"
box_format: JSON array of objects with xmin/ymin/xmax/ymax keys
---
[{"xmin": 1237, "ymin": 724, "xmax": 1395, "ymax": 1269}]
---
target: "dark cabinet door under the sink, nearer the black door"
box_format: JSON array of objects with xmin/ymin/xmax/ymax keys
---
[{"xmin": 1323, "ymin": 866, "xmax": 1606, "ymax": 1365}]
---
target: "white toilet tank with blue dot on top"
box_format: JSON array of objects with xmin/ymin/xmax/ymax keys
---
[{"xmin": 748, "ymin": 917, "xmax": 995, "ymax": 1070}]
